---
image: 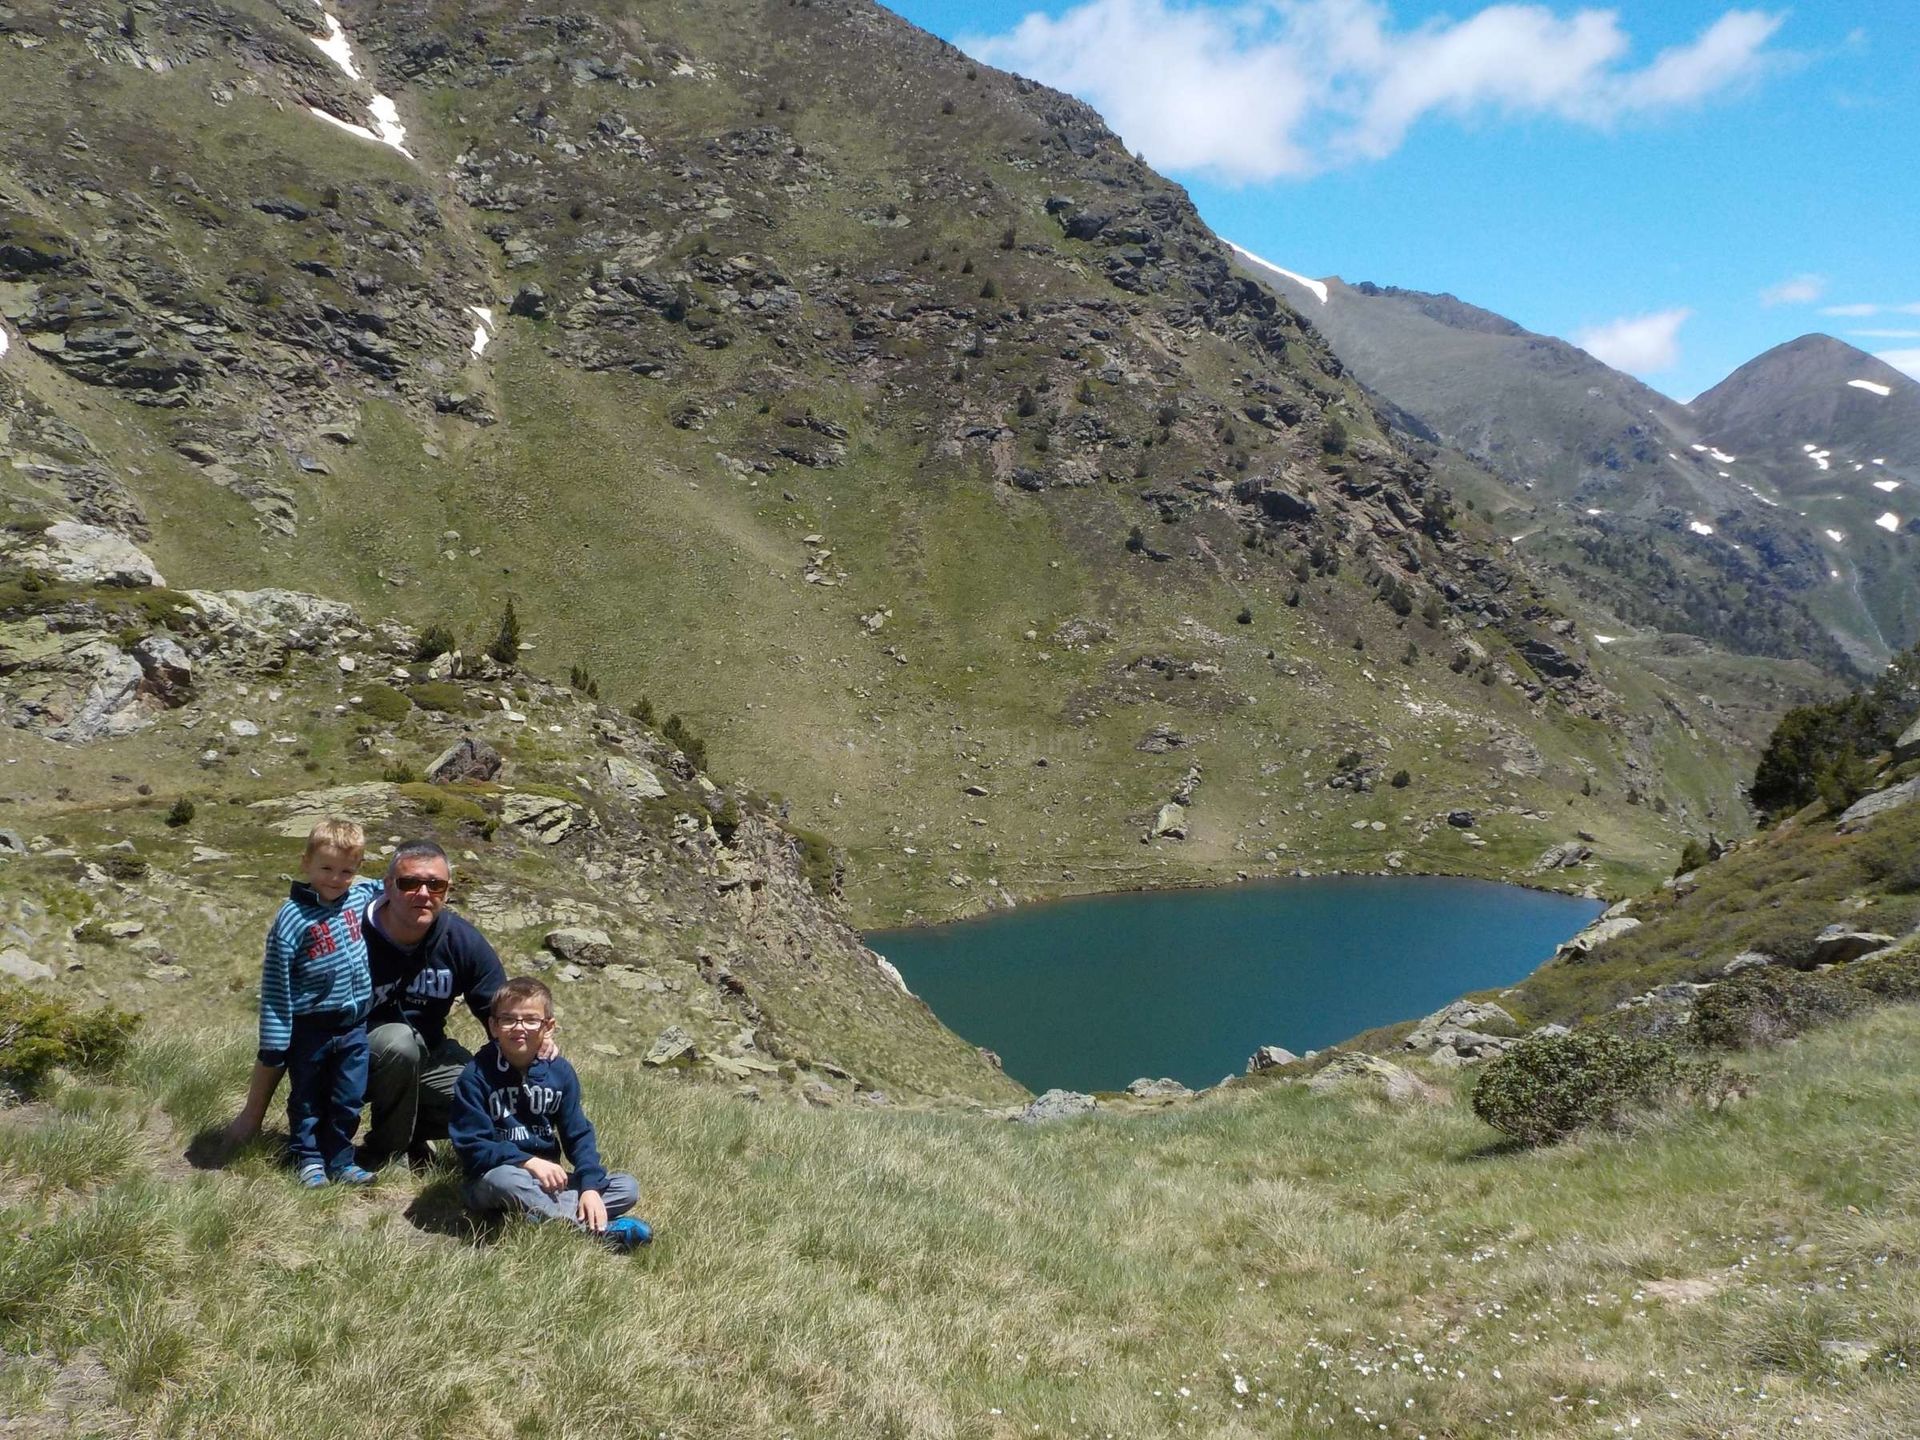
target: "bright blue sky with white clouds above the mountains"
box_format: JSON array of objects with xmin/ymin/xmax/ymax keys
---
[{"xmin": 889, "ymin": 0, "xmax": 1920, "ymax": 399}]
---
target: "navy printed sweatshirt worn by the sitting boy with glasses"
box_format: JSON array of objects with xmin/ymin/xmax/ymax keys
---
[{"xmin": 447, "ymin": 1041, "xmax": 607, "ymax": 1190}]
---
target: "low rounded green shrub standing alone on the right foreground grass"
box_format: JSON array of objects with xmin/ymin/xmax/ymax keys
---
[{"xmin": 1473, "ymin": 1029, "xmax": 1722, "ymax": 1144}]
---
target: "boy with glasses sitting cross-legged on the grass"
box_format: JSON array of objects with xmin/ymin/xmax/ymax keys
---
[{"xmin": 447, "ymin": 975, "xmax": 653, "ymax": 1250}]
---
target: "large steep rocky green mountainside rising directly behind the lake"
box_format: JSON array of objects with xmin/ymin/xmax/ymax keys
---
[{"xmin": 0, "ymin": 0, "xmax": 1766, "ymax": 948}]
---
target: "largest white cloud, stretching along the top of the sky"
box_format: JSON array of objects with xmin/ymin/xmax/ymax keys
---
[{"xmin": 962, "ymin": 0, "xmax": 1786, "ymax": 180}]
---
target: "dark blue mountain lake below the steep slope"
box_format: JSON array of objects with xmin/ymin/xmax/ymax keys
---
[{"xmin": 866, "ymin": 876, "xmax": 1601, "ymax": 1091}]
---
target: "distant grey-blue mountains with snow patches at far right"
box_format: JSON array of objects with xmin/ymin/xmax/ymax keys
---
[{"xmin": 1242, "ymin": 257, "xmax": 1920, "ymax": 674}]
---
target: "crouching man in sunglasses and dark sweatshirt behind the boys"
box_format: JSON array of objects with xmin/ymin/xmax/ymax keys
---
[{"xmin": 361, "ymin": 839, "xmax": 507, "ymax": 1169}]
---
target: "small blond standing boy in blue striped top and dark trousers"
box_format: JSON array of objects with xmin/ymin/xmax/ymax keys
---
[{"xmin": 241, "ymin": 820, "xmax": 376, "ymax": 1188}]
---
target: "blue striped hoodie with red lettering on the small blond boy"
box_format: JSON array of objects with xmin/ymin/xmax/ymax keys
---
[{"xmin": 259, "ymin": 879, "xmax": 380, "ymax": 1066}]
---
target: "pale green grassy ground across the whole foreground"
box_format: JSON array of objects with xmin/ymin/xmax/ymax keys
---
[{"xmin": 0, "ymin": 1008, "xmax": 1920, "ymax": 1440}]
